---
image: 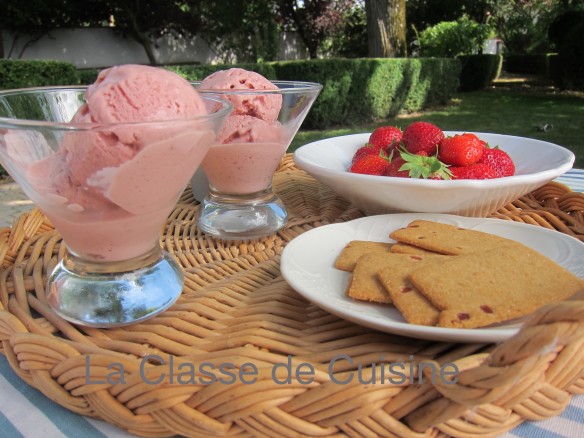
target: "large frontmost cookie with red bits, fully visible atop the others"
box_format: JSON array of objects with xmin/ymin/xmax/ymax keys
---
[{"xmin": 410, "ymin": 244, "xmax": 584, "ymax": 328}]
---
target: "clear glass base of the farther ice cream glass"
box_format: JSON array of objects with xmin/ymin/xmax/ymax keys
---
[{"xmin": 198, "ymin": 187, "xmax": 288, "ymax": 240}]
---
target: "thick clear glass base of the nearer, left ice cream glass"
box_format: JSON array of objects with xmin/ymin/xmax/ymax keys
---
[{"xmin": 47, "ymin": 247, "xmax": 184, "ymax": 328}]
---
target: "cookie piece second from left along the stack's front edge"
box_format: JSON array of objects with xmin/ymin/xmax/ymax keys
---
[{"xmin": 347, "ymin": 253, "xmax": 392, "ymax": 304}]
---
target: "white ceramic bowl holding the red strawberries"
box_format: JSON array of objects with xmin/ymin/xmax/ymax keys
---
[{"xmin": 294, "ymin": 131, "xmax": 575, "ymax": 217}]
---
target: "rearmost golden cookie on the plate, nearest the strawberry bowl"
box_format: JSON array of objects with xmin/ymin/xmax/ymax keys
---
[{"xmin": 389, "ymin": 220, "xmax": 517, "ymax": 255}]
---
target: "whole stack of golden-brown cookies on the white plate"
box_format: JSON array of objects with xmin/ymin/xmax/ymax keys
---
[{"xmin": 335, "ymin": 220, "xmax": 584, "ymax": 328}]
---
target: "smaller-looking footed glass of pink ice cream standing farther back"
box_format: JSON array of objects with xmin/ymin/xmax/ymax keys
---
[{"xmin": 193, "ymin": 68, "xmax": 322, "ymax": 240}]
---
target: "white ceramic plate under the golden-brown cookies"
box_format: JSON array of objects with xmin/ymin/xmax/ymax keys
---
[{"xmin": 281, "ymin": 213, "xmax": 584, "ymax": 342}]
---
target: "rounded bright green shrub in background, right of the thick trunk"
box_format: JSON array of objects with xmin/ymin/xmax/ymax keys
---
[{"xmin": 418, "ymin": 15, "xmax": 493, "ymax": 58}]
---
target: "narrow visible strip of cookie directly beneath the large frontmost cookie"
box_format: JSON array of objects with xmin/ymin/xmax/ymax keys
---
[{"xmin": 379, "ymin": 254, "xmax": 452, "ymax": 325}]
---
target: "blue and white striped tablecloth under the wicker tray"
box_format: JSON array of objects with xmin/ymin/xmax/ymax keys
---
[{"xmin": 0, "ymin": 169, "xmax": 584, "ymax": 438}]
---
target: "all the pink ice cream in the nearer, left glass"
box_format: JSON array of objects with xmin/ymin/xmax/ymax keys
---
[{"xmin": 29, "ymin": 65, "xmax": 214, "ymax": 260}]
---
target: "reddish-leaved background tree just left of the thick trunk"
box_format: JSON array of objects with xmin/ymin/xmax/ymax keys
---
[{"xmin": 278, "ymin": 0, "xmax": 354, "ymax": 59}]
